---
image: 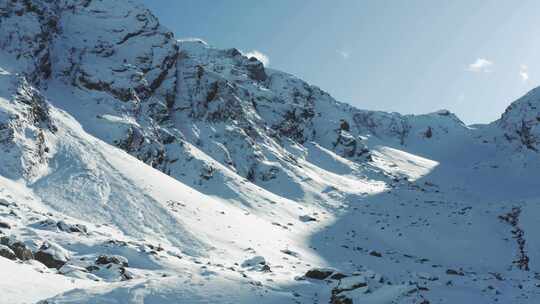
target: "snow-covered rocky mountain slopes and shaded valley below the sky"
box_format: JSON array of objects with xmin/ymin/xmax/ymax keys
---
[{"xmin": 0, "ymin": 0, "xmax": 540, "ymax": 304}]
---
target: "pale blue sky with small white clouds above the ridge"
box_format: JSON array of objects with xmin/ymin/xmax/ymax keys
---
[{"xmin": 143, "ymin": 0, "xmax": 540, "ymax": 124}]
